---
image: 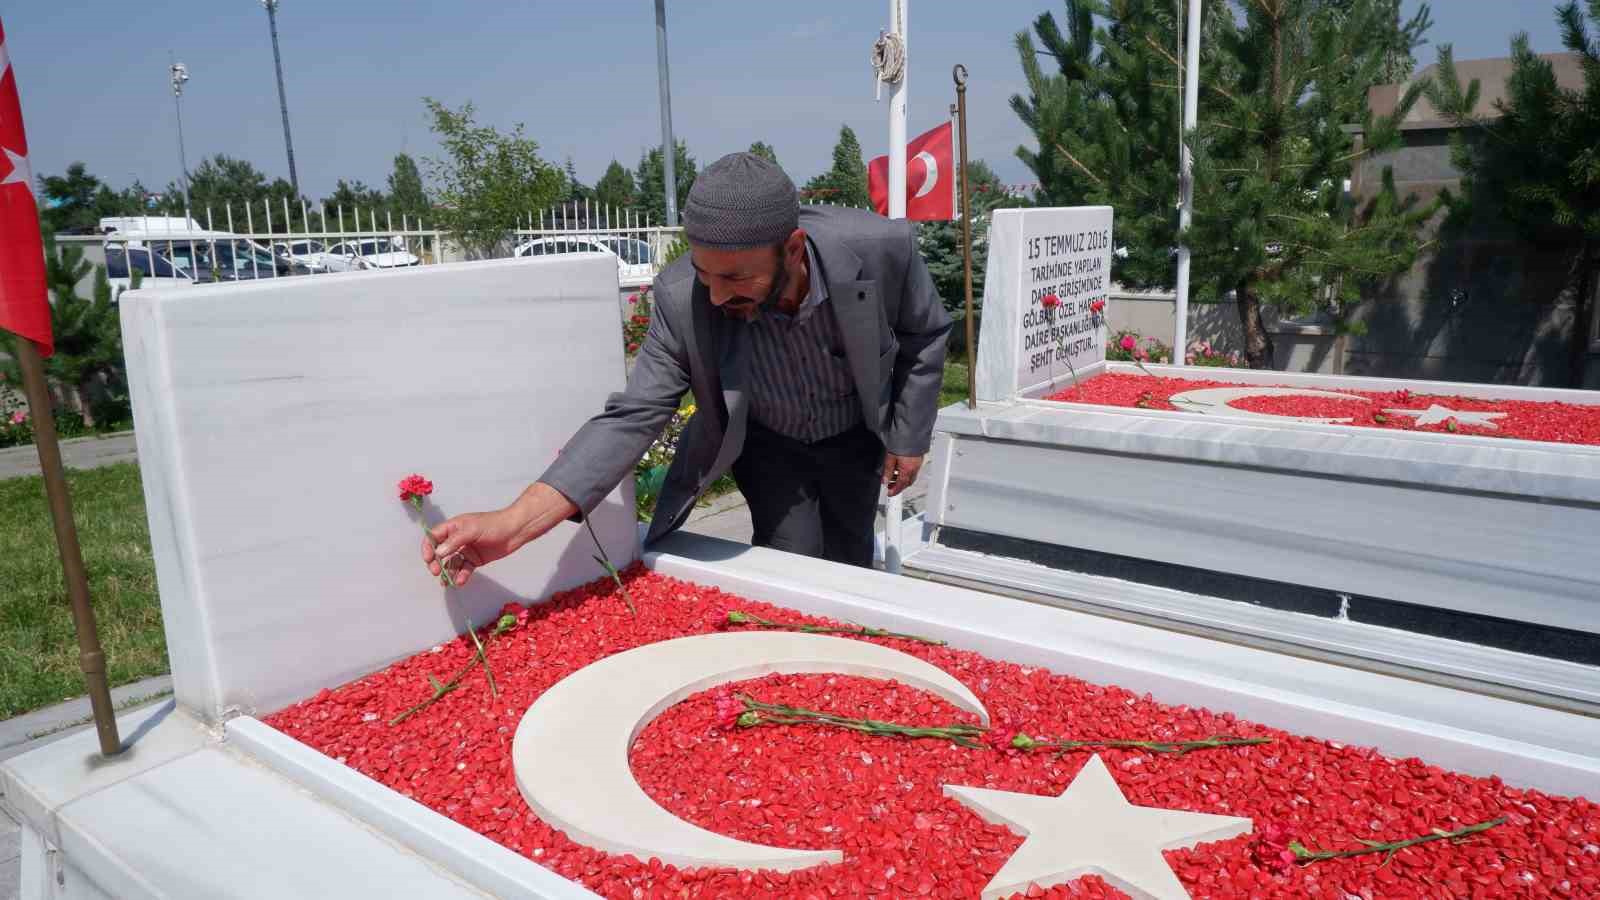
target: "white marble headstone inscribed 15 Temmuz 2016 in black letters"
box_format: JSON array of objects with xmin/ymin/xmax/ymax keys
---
[{"xmin": 976, "ymin": 207, "xmax": 1112, "ymax": 400}]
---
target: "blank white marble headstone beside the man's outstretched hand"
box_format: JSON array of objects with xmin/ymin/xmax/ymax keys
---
[{"xmin": 122, "ymin": 255, "xmax": 638, "ymax": 719}]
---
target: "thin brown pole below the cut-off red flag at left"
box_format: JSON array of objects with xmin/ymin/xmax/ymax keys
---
[{"xmin": 13, "ymin": 336, "xmax": 122, "ymax": 756}]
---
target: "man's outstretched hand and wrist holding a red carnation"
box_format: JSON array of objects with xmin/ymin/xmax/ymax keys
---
[{"xmin": 422, "ymin": 482, "xmax": 578, "ymax": 588}]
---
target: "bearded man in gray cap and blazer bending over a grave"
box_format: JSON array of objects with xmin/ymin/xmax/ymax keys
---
[{"xmin": 422, "ymin": 154, "xmax": 950, "ymax": 585}]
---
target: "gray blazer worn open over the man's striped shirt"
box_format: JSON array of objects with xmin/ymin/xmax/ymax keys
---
[{"xmin": 539, "ymin": 207, "xmax": 950, "ymax": 541}]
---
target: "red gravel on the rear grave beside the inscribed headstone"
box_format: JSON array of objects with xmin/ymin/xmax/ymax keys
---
[{"xmin": 1046, "ymin": 373, "xmax": 1600, "ymax": 444}]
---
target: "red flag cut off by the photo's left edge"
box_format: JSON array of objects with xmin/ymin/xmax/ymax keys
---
[{"xmin": 0, "ymin": 16, "xmax": 54, "ymax": 356}]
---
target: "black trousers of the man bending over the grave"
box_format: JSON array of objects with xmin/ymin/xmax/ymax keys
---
[{"xmin": 733, "ymin": 421, "xmax": 883, "ymax": 567}]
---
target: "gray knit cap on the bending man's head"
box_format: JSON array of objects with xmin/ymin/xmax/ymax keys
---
[{"xmin": 683, "ymin": 154, "xmax": 800, "ymax": 250}]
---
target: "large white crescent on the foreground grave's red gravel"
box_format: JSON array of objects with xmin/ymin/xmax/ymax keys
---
[{"xmin": 510, "ymin": 631, "xmax": 989, "ymax": 871}]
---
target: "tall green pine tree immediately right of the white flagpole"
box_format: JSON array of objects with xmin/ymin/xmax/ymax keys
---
[{"xmin": 1184, "ymin": 0, "xmax": 1437, "ymax": 368}]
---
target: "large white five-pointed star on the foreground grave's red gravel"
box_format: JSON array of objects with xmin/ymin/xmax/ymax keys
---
[{"xmin": 944, "ymin": 754, "xmax": 1251, "ymax": 900}]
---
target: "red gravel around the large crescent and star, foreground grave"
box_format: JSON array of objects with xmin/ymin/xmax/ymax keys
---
[{"xmin": 267, "ymin": 565, "xmax": 1600, "ymax": 900}]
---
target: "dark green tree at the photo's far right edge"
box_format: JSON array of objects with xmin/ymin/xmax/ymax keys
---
[{"xmin": 1429, "ymin": 0, "xmax": 1600, "ymax": 386}]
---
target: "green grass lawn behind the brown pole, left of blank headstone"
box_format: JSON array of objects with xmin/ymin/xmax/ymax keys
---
[{"xmin": 0, "ymin": 463, "xmax": 166, "ymax": 719}]
